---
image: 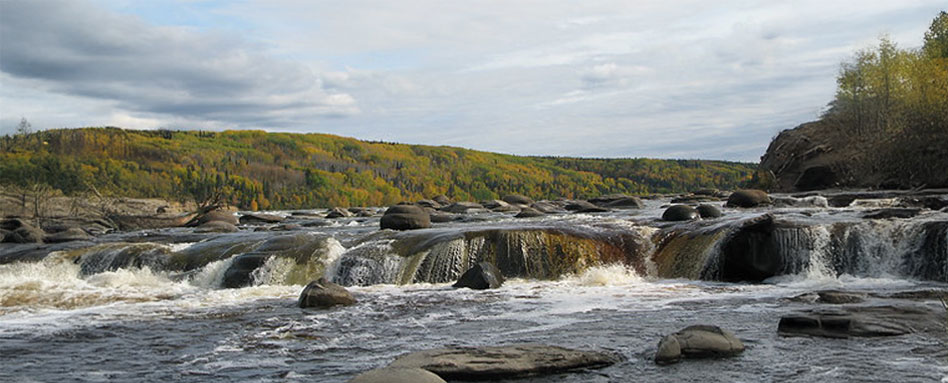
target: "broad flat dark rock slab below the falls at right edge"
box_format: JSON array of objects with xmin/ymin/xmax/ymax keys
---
[{"xmin": 777, "ymin": 304, "xmax": 945, "ymax": 338}]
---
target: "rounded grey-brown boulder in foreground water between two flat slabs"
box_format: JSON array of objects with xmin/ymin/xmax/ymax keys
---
[{"xmin": 655, "ymin": 325, "xmax": 744, "ymax": 364}]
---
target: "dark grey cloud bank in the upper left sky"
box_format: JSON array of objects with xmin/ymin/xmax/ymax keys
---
[{"xmin": 0, "ymin": 0, "xmax": 358, "ymax": 127}]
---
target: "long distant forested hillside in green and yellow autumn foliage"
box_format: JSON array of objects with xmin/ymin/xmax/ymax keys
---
[{"xmin": 0, "ymin": 128, "xmax": 755, "ymax": 209}]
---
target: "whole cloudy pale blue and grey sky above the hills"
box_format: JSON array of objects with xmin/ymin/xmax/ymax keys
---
[{"xmin": 0, "ymin": 0, "xmax": 946, "ymax": 162}]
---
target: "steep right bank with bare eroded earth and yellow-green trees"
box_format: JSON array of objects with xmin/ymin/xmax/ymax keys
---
[{"xmin": 760, "ymin": 12, "xmax": 948, "ymax": 191}]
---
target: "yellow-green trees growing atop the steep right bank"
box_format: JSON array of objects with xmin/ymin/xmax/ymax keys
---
[{"xmin": 822, "ymin": 11, "xmax": 948, "ymax": 186}]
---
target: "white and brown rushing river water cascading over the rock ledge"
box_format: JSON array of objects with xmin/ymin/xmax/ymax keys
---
[{"xmin": 0, "ymin": 196, "xmax": 948, "ymax": 382}]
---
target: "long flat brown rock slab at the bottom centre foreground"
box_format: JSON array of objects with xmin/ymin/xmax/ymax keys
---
[{"xmin": 391, "ymin": 344, "xmax": 619, "ymax": 380}]
